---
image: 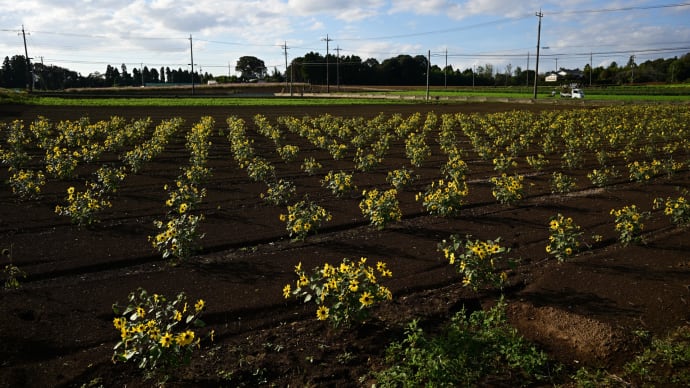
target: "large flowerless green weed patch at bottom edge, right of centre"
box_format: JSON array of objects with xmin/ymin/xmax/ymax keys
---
[{"xmin": 374, "ymin": 299, "xmax": 555, "ymax": 387}]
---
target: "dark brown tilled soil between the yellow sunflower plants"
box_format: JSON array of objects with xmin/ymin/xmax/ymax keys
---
[{"xmin": 0, "ymin": 103, "xmax": 690, "ymax": 387}]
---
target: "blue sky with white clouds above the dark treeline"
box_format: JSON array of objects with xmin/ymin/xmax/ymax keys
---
[{"xmin": 0, "ymin": 0, "xmax": 690, "ymax": 82}]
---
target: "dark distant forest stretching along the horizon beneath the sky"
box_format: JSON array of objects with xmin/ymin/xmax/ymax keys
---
[{"xmin": 0, "ymin": 52, "xmax": 690, "ymax": 90}]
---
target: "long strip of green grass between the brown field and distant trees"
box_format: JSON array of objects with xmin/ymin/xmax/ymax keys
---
[{"xmin": 0, "ymin": 84, "xmax": 690, "ymax": 106}]
